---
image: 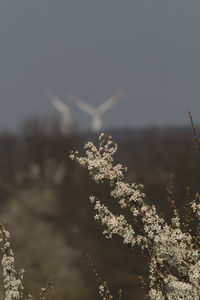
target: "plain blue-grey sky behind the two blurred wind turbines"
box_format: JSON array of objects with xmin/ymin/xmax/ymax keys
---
[{"xmin": 0, "ymin": 0, "xmax": 200, "ymax": 128}]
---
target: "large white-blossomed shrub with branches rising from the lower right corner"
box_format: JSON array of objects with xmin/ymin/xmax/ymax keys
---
[{"xmin": 70, "ymin": 134, "xmax": 200, "ymax": 300}]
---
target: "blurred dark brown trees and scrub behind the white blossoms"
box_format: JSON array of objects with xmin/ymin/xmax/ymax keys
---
[{"xmin": 0, "ymin": 119, "xmax": 200, "ymax": 300}]
